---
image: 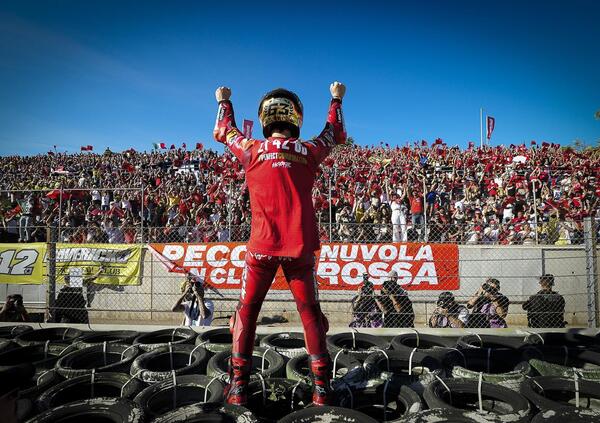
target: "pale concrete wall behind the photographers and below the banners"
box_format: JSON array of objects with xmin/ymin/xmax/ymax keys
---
[{"xmin": 0, "ymin": 246, "xmax": 600, "ymax": 326}]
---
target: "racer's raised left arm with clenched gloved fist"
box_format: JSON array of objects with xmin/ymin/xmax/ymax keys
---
[{"xmin": 213, "ymin": 87, "xmax": 254, "ymax": 166}]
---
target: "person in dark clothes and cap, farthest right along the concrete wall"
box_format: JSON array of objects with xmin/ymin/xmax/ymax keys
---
[{"xmin": 523, "ymin": 273, "xmax": 566, "ymax": 328}]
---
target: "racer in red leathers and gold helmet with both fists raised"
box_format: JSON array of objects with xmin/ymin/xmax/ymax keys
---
[{"xmin": 214, "ymin": 82, "xmax": 346, "ymax": 405}]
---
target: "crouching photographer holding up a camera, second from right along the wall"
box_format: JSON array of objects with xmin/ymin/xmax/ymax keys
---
[{"xmin": 467, "ymin": 278, "xmax": 510, "ymax": 329}]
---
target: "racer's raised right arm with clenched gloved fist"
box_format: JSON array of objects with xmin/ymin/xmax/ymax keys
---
[{"xmin": 303, "ymin": 82, "xmax": 346, "ymax": 164}]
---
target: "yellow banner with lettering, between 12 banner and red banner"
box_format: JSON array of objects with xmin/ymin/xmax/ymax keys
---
[{"xmin": 56, "ymin": 244, "xmax": 142, "ymax": 286}]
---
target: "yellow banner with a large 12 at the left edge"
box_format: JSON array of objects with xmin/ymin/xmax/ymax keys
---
[{"xmin": 0, "ymin": 242, "xmax": 46, "ymax": 284}]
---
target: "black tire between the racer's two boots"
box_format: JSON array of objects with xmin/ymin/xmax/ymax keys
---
[{"xmin": 246, "ymin": 378, "xmax": 312, "ymax": 422}]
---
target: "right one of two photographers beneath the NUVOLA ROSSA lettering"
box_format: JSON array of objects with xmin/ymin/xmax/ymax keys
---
[{"xmin": 375, "ymin": 270, "xmax": 415, "ymax": 328}]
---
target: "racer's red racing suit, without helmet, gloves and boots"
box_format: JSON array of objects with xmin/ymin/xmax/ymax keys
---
[{"xmin": 214, "ymin": 99, "xmax": 346, "ymax": 356}]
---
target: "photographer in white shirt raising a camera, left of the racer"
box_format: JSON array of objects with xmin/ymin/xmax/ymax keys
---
[{"xmin": 171, "ymin": 273, "xmax": 214, "ymax": 326}]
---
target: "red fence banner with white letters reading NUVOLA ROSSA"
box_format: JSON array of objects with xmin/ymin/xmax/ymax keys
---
[{"xmin": 150, "ymin": 242, "xmax": 459, "ymax": 291}]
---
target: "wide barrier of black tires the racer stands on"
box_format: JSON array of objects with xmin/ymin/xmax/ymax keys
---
[{"xmin": 0, "ymin": 326, "xmax": 600, "ymax": 423}]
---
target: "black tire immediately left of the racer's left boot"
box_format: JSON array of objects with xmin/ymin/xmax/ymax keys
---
[{"xmin": 134, "ymin": 375, "xmax": 225, "ymax": 418}]
